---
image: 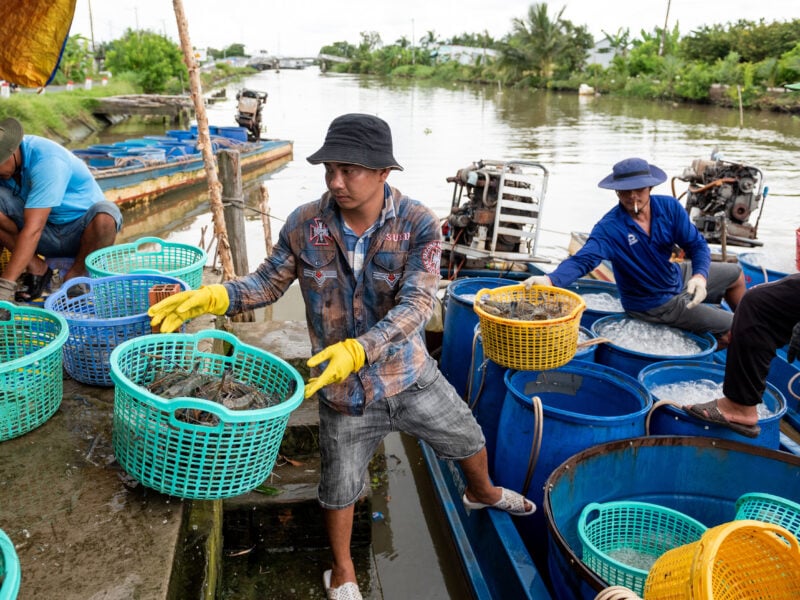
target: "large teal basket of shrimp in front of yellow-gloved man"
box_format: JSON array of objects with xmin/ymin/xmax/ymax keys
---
[{"xmin": 111, "ymin": 330, "xmax": 304, "ymax": 500}]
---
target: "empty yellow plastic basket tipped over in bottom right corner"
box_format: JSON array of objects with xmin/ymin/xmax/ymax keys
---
[{"xmin": 644, "ymin": 520, "xmax": 800, "ymax": 600}]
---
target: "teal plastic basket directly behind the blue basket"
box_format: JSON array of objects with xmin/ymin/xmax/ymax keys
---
[{"xmin": 86, "ymin": 237, "xmax": 207, "ymax": 290}]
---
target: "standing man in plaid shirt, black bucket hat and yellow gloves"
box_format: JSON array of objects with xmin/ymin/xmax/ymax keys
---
[{"xmin": 149, "ymin": 114, "xmax": 536, "ymax": 599}]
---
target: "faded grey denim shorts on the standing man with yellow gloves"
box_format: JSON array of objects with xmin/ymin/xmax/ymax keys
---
[{"xmin": 317, "ymin": 359, "xmax": 486, "ymax": 509}]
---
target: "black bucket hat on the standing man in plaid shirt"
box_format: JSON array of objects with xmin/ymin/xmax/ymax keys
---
[{"xmin": 306, "ymin": 113, "xmax": 403, "ymax": 171}]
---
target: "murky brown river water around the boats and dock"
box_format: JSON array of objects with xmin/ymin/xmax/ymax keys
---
[{"xmin": 94, "ymin": 68, "xmax": 800, "ymax": 599}]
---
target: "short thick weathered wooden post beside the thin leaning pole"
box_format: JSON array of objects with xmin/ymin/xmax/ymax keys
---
[{"xmin": 217, "ymin": 150, "xmax": 255, "ymax": 323}]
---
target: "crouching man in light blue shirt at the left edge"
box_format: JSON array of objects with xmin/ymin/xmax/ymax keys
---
[{"xmin": 0, "ymin": 118, "xmax": 122, "ymax": 301}]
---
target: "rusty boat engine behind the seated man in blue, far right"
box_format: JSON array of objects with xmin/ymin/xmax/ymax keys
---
[{"xmin": 678, "ymin": 158, "xmax": 763, "ymax": 246}]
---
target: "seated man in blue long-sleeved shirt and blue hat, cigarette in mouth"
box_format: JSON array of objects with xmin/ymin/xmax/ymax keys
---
[{"xmin": 525, "ymin": 158, "xmax": 745, "ymax": 349}]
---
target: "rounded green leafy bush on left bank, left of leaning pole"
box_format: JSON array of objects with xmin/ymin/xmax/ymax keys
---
[{"xmin": 106, "ymin": 29, "xmax": 188, "ymax": 94}]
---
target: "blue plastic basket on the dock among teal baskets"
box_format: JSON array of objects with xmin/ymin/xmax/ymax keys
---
[{"xmin": 44, "ymin": 275, "xmax": 187, "ymax": 387}]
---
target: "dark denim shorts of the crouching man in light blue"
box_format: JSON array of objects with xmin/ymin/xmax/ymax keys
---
[{"xmin": 0, "ymin": 193, "xmax": 122, "ymax": 258}]
